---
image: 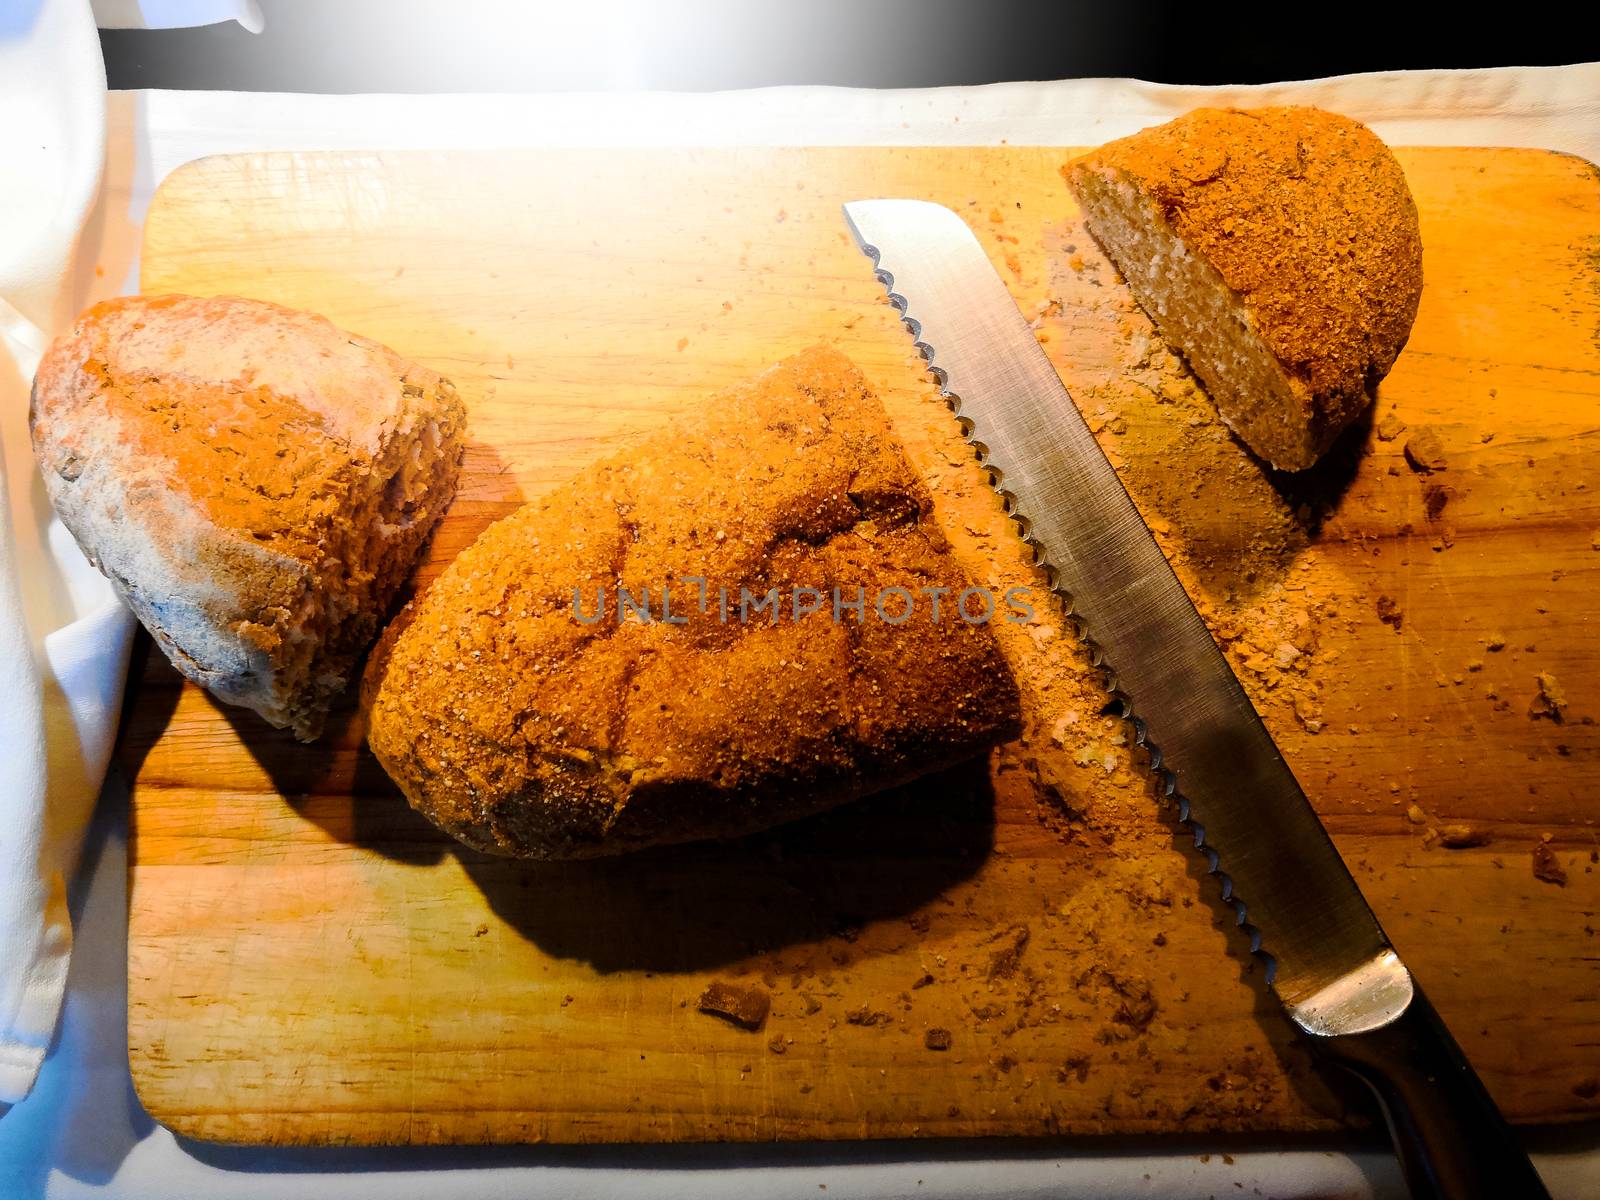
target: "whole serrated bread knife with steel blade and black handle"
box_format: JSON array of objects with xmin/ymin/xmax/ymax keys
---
[{"xmin": 845, "ymin": 200, "xmax": 1547, "ymax": 1198}]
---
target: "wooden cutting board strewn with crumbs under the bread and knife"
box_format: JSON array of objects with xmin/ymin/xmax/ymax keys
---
[{"xmin": 120, "ymin": 147, "xmax": 1600, "ymax": 1142}]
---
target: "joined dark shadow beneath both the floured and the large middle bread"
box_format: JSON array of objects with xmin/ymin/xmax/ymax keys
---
[{"xmin": 204, "ymin": 611, "xmax": 995, "ymax": 973}]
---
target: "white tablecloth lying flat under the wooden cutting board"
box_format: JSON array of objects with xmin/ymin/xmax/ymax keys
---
[{"xmin": 0, "ymin": 64, "xmax": 1600, "ymax": 1200}]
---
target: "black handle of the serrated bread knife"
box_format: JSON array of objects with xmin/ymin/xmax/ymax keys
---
[{"xmin": 1312, "ymin": 990, "xmax": 1550, "ymax": 1200}]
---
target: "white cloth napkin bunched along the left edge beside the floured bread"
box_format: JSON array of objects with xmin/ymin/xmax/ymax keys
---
[{"xmin": 0, "ymin": 2, "xmax": 133, "ymax": 1112}]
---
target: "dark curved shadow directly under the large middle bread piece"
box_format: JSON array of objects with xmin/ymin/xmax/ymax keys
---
[{"xmin": 458, "ymin": 758, "xmax": 995, "ymax": 971}]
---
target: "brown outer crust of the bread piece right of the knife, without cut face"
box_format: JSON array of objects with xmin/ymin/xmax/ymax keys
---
[{"xmin": 1062, "ymin": 107, "xmax": 1422, "ymax": 469}]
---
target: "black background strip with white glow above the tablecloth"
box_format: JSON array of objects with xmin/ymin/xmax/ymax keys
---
[{"xmin": 101, "ymin": 0, "xmax": 1600, "ymax": 93}]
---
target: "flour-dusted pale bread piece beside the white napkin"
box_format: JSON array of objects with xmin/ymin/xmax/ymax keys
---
[{"xmin": 30, "ymin": 296, "xmax": 466, "ymax": 741}]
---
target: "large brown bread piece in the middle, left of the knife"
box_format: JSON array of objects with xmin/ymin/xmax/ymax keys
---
[{"xmin": 363, "ymin": 349, "xmax": 1042, "ymax": 858}]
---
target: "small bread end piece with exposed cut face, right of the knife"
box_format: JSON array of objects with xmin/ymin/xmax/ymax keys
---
[{"xmin": 1062, "ymin": 107, "xmax": 1422, "ymax": 470}]
